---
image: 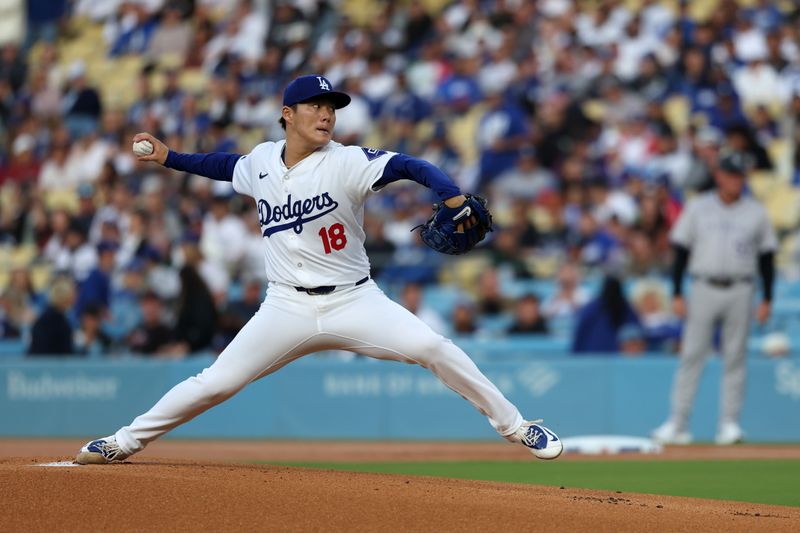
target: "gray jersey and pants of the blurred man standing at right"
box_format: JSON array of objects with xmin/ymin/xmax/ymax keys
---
[{"xmin": 671, "ymin": 192, "xmax": 777, "ymax": 430}]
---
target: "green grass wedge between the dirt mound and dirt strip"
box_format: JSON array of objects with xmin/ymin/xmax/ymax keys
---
[{"xmin": 274, "ymin": 460, "xmax": 800, "ymax": 507}]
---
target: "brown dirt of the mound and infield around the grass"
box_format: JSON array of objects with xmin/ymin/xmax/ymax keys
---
[{"xmin": 0, "ymin": 440, "xmax": 800, "ymax": 532}]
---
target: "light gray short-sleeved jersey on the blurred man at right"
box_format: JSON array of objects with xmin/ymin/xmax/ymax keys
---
[{"xmin": 671, "ymin": 191, "xmax": 777, "ymax": 277}]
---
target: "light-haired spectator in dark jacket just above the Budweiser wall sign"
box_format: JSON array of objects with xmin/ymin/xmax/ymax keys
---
[{"xmin": 28, "ymin": 277, "xmax": 75, "ymax": 356}]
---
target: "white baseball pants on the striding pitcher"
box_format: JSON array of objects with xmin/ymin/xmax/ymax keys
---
[{"xmin": 115, "ymin": 280, "xmax": 523, "ymax": 454}]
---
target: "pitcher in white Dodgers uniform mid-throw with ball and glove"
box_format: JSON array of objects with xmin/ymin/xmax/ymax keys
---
[{"xmin": 76, "ymin": 75, "xmax": 562, "ymax": 464}]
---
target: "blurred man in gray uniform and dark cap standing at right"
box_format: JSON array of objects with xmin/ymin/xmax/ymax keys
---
[{"xmin": 652, "ymin": 152, "xmax": 777, "ymax": 444}]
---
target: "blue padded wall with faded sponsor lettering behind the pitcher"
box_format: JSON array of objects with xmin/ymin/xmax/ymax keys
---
[{"xmin": 0, "ymin": 357, "xmax": 800, "ymax": 442}]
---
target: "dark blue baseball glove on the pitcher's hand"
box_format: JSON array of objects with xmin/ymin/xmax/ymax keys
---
[{"xmin": 414, "ymin": 194, "xmax": 492, "ymax": 255}]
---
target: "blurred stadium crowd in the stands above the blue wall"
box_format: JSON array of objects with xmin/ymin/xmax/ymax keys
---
[{"xmin": 0, "ymin": 0, "xmax": 800, "ymax": 357}]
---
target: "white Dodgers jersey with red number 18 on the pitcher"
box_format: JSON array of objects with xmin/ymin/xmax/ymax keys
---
[{"xmin": 233, "ymin": 141, "xmax": 395, "ymax": 287}]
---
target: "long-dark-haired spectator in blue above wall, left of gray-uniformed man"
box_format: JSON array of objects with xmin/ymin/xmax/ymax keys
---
[{"xmin": 572, "ymin": 276, "xmax": 641, "ymax": 353}]
